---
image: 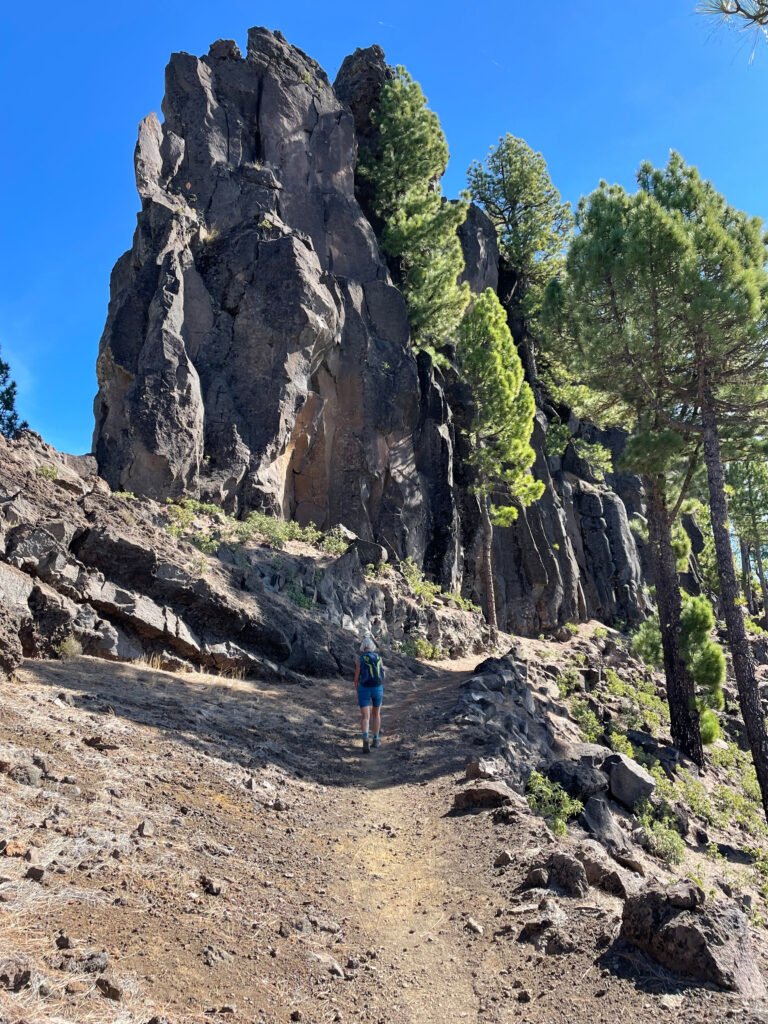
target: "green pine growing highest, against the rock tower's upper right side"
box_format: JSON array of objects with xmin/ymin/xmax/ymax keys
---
[{"xmin": 360, "ymin": 68, "xmax": 469, "ymax": 354}]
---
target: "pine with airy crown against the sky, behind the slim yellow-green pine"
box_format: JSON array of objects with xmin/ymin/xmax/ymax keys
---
[{"xmin": 467, "ymin": 134, "xmax": 573, "ymax": 386}]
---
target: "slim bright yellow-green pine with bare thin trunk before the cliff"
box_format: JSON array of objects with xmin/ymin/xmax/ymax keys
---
[{"xmin": 457, "ymin": 288, "xmax": 544, "ymax": 640}]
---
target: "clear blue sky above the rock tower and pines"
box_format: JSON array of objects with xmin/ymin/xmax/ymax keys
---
[{"xmin": 0, "ymin": 0, "xmax": 768, "ymax": 453}]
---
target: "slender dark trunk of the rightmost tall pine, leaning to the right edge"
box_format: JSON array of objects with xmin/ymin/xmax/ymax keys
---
[{"xmin": 701, "ymin": 388, "xmax": 768, "ymax": 818}]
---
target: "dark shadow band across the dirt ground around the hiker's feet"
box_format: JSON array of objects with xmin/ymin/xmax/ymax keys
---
[{"xmin": 20, "ymin": 657, "xmax": 481, "ymax": 790}]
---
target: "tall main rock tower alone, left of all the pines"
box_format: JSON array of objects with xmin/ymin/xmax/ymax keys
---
[{"xmin": 94, "ymin": 29, "xmax": 425, "ymax": 557}]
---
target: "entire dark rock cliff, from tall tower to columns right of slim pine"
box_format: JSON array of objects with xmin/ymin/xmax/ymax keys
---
[{"xmin": 94, "ymin": 29, "xmax": 643, "ymax": 633}]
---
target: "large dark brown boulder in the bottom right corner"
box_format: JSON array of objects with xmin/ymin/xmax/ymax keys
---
[{"xmin": 621, "ymin": 883, "xmax": 768, "ymax": 999}]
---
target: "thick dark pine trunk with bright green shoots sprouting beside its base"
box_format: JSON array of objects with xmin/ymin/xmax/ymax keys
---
[{"xmin": 646, "ymin": 479, "xmax": 703, "ymax": 765}]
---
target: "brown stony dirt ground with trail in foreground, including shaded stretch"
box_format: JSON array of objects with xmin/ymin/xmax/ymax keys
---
[{"xmin": 0, "ymin": 657, "xmax": 768, "ymax": 1024}]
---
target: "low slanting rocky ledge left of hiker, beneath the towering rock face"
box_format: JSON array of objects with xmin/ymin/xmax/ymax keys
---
[{"xmin": 0, "ymin": 432, "xmax": 487, "ymax": 683}]
